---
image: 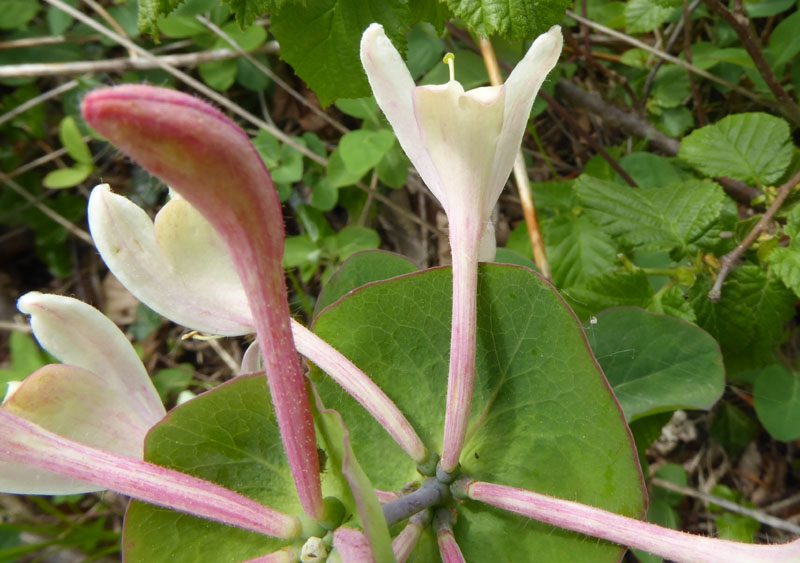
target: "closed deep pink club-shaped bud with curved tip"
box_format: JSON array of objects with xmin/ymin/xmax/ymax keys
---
[{"xmin": 82, "ymin": 86, "xmax": 325, "ymax": 520}]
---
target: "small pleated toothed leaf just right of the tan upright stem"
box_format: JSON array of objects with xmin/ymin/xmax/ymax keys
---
[{"xmin": 544, "ymin": 215, "xmax": 617, "ymax": 287}]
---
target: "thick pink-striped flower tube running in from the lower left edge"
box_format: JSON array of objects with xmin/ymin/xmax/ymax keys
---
[{"xmin": 0, "ymin": 409, "xmax": 301, "ymax": 539}]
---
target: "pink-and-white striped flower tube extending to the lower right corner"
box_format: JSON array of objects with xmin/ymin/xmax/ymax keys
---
[{"xmin": 451, "ymin": 478, "xmax": 800, "ymax": 563}]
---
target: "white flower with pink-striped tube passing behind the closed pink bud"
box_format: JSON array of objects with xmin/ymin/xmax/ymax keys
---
[{"xmin": 88, "ymin": 184, "xmax": 428, "ymax": 463}]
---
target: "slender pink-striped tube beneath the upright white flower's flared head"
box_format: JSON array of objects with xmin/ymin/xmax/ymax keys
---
[{"xmin": 439, "ymin": 225, "xmax": 482, "ymax": 474}]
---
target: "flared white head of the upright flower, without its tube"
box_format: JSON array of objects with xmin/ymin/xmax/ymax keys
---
[{"xmin": 361, "ymin": 24, "xmax": 562, "ymax": 256}]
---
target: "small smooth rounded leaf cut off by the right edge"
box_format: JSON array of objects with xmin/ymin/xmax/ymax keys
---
[{"xmin": 753, "ymin": 364, "xmax": 800, "ymax": 442}]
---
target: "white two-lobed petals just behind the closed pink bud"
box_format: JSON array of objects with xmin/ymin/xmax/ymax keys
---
[{"xmin": 88, "ymin": 184, "xmax": 255, "ymax": 336}]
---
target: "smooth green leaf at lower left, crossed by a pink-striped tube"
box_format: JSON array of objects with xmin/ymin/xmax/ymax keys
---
[{"xmin": 123, "ymin": 376, "xmax": 302, "ymax": 563}]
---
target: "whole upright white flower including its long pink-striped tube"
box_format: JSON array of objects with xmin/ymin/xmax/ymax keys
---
[{"xmin": 361, "ymin": 24, "xmax": 562, "ymax": 480}]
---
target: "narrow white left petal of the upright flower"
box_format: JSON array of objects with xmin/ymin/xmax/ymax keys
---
[{"xmin": 361, "ymin": 23, "xmax": 444, "ymax": 205}]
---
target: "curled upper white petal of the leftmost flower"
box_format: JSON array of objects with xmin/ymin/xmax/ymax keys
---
[{"xmin": 12, "ymin": 291, "xmax": 166, "ymax": 428}]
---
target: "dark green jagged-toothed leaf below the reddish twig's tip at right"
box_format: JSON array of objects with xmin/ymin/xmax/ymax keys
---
[{"xmin": 689, "ymin": 264, "xmax": 795, "ymax": 374}]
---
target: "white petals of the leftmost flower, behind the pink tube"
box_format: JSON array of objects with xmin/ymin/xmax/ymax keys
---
[{"xmin": 0, "ymin": 292, "xmax": 166, "ymax": 494}]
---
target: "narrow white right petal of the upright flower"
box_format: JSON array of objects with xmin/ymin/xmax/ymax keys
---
[{"xmin": 485, "ymin": 25, "xmax": 563, "ymax": 206}]
